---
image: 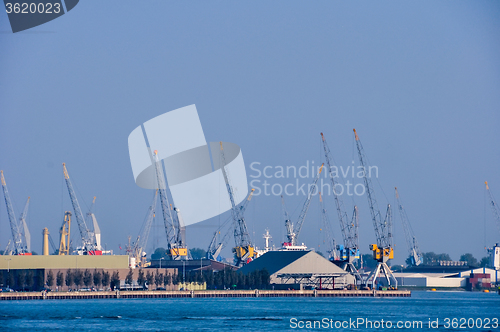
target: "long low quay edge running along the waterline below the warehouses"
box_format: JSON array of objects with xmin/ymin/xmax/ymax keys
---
[{"xmin": 0, "ymin": 289, "xmax": 411, "ymax": 301}]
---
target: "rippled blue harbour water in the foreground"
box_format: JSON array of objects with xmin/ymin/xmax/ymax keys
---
[{"xmin": 0, "ymin": 291, "xmax": 500, "ymax": 332}]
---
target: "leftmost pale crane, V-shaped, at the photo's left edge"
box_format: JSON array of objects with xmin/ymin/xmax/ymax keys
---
[{"xmin": 0, "ymin": 171, "xmax": 31, "ymax": 255}]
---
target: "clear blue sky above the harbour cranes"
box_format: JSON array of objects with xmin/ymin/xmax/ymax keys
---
[{"xmin": 0, "ymin": 0, "xmax": 500, "ymax": 264}]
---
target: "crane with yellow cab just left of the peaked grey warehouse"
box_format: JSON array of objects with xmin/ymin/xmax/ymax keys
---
[{"xmin": 220, "ymin": 142, "xmax": 254, "ymax": 266}]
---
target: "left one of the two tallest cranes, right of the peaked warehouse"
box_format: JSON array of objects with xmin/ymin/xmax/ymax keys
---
[{"xmin": 321, "ymin": 133, "xmax": 363, "ymax": 284}]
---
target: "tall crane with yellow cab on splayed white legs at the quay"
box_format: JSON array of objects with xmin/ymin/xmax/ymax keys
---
[{"xmin": 353, "ymin": 129, "xmax": 398, "ymax": 289}]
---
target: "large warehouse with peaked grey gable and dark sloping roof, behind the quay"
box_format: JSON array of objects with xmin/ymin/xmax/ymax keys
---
[{"xmin": 239, "ymin": 250, "xmax": 355, "ymax": 289}]
